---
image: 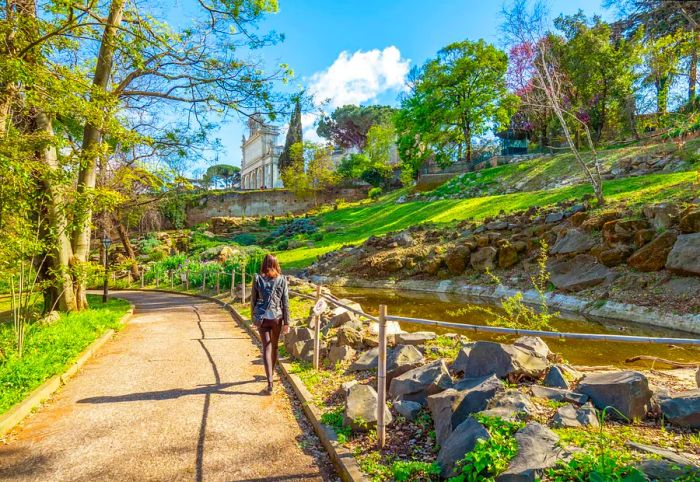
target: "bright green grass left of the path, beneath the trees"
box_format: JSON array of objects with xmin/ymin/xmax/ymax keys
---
[{"xmin": 0, "ymin": 295, "xmax": 129, "ymax": 413}]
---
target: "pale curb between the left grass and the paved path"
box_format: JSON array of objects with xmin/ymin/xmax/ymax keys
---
[{"xmin": 0, "ymin": 306, "xmax": 134, "ymax": 437}]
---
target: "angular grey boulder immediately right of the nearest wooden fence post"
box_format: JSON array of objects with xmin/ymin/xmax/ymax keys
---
[{"xmin": 389, "ymin": 360, "xmax": 452, "ymax": 405}]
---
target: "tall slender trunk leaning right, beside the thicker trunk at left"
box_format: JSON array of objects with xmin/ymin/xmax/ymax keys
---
[{"xmin": 73, "ymin": 0, "xmax": 126, "ymax": 309}]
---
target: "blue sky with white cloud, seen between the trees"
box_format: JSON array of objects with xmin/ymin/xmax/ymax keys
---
[{"xmin": 196, "ymin": 0, "xmax": 613, "ymax": 174}]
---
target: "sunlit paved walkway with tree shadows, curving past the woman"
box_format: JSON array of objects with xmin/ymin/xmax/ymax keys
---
[{"xmin": 0, "ymin": 292, "xmax": 334, "ymax": 481}]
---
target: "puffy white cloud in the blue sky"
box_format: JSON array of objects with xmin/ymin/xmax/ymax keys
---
[{"xmin": 308, "ymin": 45, "xmax": 410, "ymax": 109}]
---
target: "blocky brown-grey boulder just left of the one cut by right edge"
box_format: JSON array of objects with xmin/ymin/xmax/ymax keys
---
[{"xmin": 577, "ymin": 370, "xmax": 652, "ymax": 421}]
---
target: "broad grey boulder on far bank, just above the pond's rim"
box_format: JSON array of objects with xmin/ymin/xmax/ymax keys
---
[{"xmin": 547, "ymin": 254, "xmax": 613, "ymax": 291}]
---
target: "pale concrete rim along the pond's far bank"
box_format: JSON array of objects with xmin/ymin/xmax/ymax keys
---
[{"xmin": 308, "ymin": 275, "xmax": 700, "ymax": 335}]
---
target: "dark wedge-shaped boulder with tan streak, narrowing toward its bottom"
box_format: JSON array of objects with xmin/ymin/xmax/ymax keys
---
[{"xmin": 428, "ymin": 375, "xmax": 503, "ymax": 445}]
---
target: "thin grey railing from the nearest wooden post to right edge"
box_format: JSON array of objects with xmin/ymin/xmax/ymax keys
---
[{"xmin": 386, "ymin": 316, "xmax": 700, "ymax": 346}]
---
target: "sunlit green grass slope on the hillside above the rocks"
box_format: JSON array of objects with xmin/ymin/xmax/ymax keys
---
[{"xmin": 277, "ymin": 168, "xmax": 698, "ymax": 268}]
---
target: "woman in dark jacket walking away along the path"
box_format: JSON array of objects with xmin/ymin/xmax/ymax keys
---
[{"xmin": 250, "ymin": 254, "xmax": 289, "ymax": 394}]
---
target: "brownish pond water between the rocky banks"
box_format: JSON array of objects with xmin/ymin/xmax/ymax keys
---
[{"xmin": 333, "ymin": 288, "xmax": 700, "ymax": 368}]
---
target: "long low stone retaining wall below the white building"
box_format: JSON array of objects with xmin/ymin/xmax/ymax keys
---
[{"xmin": 185, "ymin": 187, "xmax": 367, "ymax": 227}]
